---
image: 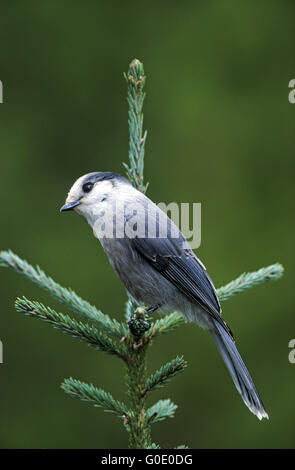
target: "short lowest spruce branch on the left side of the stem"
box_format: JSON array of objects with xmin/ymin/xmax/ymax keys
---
[{"xmin": 61, "ymin": 377, "xmax": 132, "ymax": 423}]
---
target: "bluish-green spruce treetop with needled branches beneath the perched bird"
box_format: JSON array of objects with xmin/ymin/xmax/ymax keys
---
[{"xmin": 0, "ymin": 59, "xmax": 283, "ymax": 449}]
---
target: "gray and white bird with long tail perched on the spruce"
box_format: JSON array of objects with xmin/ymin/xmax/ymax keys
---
[{"xmin": 60, "ymin": 171, "xmax": 268, "ymax": 420}]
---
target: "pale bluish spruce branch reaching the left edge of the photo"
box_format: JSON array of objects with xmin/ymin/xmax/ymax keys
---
[{"xmin": 0, "ymin": 250, "xmax": 125, "ymax": 339}]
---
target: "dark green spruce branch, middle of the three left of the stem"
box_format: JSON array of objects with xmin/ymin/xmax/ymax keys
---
[{"xmin": 15, "ymin": 297, "xmax": 128, "ymax": 360}]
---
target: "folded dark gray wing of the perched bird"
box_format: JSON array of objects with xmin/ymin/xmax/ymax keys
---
[{"xmin": 130, "ymin": 237, "xmax": 233, "ymax": 337}]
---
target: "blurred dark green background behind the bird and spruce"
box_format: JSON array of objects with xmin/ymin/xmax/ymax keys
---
[{"xmin": 0, "ymin": 0, "xmax": 295, "ymax": 448}]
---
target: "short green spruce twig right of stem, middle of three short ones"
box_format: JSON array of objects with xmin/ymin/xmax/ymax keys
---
[{"xmin": 141, "ymin": 356, "xmax": 187, "ymax": 396}]
